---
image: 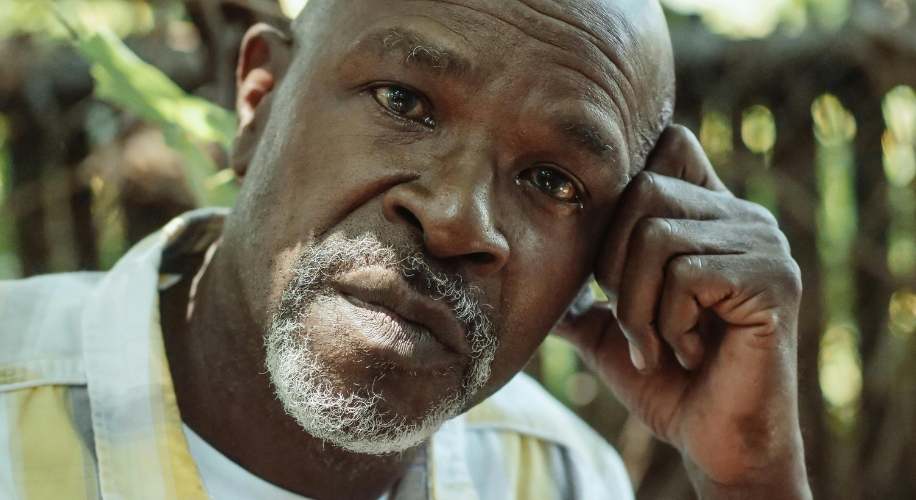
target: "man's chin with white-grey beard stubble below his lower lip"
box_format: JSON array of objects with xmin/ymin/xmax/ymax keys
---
[{"xmin": 266, "ymin": 296, "xmax": 469, "ymax": 455}]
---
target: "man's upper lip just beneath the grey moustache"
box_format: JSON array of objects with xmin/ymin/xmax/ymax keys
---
[{"xmin": 337, "ymin": 267, "xmax": 470, "ymax": 355}]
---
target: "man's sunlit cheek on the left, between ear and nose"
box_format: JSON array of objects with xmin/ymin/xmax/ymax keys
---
[{"xmin": 225, "ymin": 99, "xmax": 418, "ymax": 326}]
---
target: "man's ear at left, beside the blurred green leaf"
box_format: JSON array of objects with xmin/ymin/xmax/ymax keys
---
[{"xmin": 230, "ymin": 23, "xmax": 292, "ymax": 181}]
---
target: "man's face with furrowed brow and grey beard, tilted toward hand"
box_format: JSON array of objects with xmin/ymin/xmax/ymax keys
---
[{"xmin": 224, "ymin": 0, "xmax": 668, "ymax": 452}]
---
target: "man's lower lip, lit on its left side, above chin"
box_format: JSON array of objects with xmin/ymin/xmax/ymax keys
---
[{"xmin": 341, "ymin": 294, "xmax": 460, "ymax": 370}]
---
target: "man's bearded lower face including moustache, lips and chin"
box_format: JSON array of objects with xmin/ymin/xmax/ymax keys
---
[{"xmin": 265, "ymin": 230, "xmax": 498, "ymax": 455}]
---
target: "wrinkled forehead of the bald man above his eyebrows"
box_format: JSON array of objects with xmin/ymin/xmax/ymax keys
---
[{"xmin": 348, "ymin": 0, "xmax": 641, "ymax": 92}]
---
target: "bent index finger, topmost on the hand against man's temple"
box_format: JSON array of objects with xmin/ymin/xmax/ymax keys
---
[{"xmin": 646, "ymin": 125, "xmax": 728, "ymax": 193}]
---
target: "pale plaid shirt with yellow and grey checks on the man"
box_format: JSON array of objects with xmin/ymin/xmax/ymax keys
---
[{"xmin": 0, "ymin": 210, "xmax": 633, "ymax": 500}]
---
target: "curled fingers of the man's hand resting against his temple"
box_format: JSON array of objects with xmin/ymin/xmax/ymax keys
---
[{"xmin": 595, "ymin": 126, "xmax": 794, "ymax": 373}]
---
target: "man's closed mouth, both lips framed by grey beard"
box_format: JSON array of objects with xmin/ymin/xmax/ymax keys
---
[{"xmin": 334, "ymin": 268, "xmax": 471, "ymax": 361}]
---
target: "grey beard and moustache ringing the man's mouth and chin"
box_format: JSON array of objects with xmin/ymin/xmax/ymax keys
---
[{"xmin": 265, "ymin": 234, "xmax": 498, "ymax": 455}]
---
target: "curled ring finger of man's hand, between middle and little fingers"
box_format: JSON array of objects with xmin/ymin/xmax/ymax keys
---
[{"xmin": 617, "ymin": 218, "xmax": 748, "ymax": 371}]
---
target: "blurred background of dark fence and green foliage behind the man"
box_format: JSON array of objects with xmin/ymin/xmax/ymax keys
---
[{"xmin": 0, "ymin": 0, "xmax": 916, "ymax": 499}]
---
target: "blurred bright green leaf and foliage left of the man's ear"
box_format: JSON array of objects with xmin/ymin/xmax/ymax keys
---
[{"xmin": 0, "ymin": 0, "xmax": 237, "ymax": 206}]
